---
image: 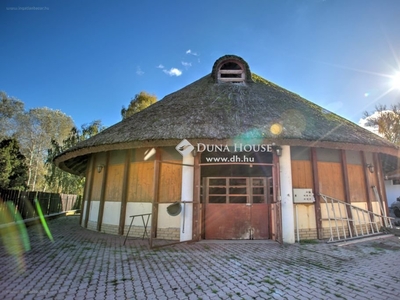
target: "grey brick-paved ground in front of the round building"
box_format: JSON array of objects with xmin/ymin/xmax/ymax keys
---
[{"xmin": 0, "ymin": 216, "xmax": 400, "ymax": 299}]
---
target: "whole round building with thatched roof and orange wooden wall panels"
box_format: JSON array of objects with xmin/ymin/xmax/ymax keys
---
[{"xmin": 55, "ymin": 55, "xmax": 399, "ymax": 243}]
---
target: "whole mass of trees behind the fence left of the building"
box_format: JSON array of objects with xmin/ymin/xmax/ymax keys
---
[{"xmin": 0, "ymin": 91, "xmax": 105, "ymax": 195}]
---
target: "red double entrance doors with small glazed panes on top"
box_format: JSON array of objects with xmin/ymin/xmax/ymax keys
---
[{"xmin": 204, "ymin": 177, "xmax": 272, "ymax": 239}]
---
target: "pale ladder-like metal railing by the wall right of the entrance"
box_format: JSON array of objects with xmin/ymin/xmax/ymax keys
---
[{"xmin": 320, "ymin": 194, "xmax": 393, "ymax": 243}]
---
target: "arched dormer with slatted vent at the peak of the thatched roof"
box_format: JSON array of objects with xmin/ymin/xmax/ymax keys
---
[{"xmin": 211, "ymin": 55, "xmax": 252, "ymax": 83}]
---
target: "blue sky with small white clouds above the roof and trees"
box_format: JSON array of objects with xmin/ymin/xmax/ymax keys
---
[{"xmin": 0, "ymin": 0, "xmax": 400, "ymax": 126}]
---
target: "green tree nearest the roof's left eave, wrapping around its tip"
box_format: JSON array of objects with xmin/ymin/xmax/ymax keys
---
[{"xmin": 45, "ymin": 120, "xmax": 105, "ymax": 195}]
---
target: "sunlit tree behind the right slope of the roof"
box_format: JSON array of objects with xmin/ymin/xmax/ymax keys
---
[{"xmin": 363, "ymin": 103, "xmax": 400, "ymax": 145}]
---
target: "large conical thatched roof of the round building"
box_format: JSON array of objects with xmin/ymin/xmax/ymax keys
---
[{"xmin": 55, "ymin": 56, "xmax": 398, "ymax": 173}]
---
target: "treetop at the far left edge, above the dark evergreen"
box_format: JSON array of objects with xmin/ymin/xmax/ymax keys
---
[{"xmin": 0, "ymin": 91, "xmax": 24, "ymax": 139}]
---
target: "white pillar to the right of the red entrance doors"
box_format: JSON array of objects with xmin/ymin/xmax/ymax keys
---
[{"xmin": 279, "ymin": 146, "xmax": 295, "ymax": 244}]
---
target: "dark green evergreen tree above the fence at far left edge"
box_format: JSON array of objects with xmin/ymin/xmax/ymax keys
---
[{"xmin": 0, "ymin": 139, "xmax": 28, "ymax": 190}]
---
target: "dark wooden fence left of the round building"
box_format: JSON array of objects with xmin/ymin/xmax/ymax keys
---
[{"xmin": 0, "ymin": 189, "xmax": 81, "ymax": 223}]
